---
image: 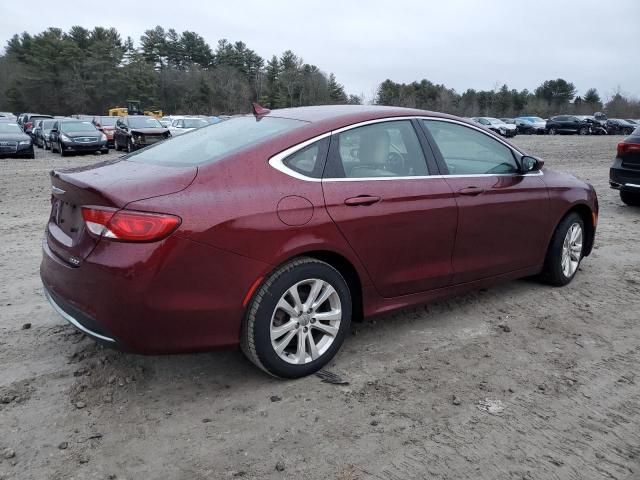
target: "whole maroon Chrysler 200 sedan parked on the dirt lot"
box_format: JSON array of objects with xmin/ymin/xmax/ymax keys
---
[{"xmin": 41, "ymin": 106, "xmax": 598, "ymax": 378}]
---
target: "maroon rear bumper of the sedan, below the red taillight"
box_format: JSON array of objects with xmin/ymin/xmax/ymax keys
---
[{"xmin": 40, "ymin": 235, "xmax": 270, "ymax": 354}]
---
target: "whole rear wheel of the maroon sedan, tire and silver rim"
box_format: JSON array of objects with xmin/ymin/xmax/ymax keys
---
[{"xmin": 240, "ymin": 257, "xmax": 352, "ymax": 378}]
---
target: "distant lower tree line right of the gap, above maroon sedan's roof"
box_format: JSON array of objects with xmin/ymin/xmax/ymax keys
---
[{"xmin": 376, "ymin": 78, "xmax": 640, "ymax": 118}]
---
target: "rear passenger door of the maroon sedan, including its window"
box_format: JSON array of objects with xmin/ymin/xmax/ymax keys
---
[{"xmin": 322, "ymin": 119, "xmax": 457, "ymax": 297}]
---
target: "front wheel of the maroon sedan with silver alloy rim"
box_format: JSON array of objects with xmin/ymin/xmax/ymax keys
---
[{"xmin": 541, "ymin": 212, "xmax": 585, "ymax": 287}]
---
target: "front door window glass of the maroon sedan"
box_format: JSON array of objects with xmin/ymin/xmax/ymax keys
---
[{"xmin": 422, "ymin": 120, "xmax": 518, "ymax": 175}]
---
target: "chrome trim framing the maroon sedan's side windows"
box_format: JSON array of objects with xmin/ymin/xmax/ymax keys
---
[{"xmin": 269, "ymin": 115, "xmax": 532, "ymax": 182}]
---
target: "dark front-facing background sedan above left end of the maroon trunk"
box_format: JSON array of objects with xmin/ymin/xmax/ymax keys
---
[{"xmin": 49, "ymin": 118, "xmax": 109, "ymax": 157}]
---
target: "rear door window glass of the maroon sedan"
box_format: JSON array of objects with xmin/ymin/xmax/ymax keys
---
[{"xmin": 325, "ymin": 120, "xmax": 429, "ymax": 178}]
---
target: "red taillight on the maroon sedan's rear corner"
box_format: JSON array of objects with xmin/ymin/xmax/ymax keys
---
[{"xmin": 82, "ymin": 207, "xmax": 181, "ymax": 242}]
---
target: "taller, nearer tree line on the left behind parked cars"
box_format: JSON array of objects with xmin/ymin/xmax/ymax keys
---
[{"xmin": 0, "ymin": 26, "xmax": 361, "ymax": 115}]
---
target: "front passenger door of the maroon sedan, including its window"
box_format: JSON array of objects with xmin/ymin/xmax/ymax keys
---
[{"xmin": 422, "ymin": 119, "xmax": 549, "ymax": 283}]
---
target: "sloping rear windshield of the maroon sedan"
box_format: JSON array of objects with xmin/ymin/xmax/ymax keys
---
[{"xmin": 129, "ymin": 116, "xmax": 306, "ymax": 166}]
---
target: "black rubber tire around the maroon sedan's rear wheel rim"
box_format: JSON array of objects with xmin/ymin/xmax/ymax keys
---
[{"xmin": 240, "ymin": 257, "xmax": 352, "ymax": 378}]
